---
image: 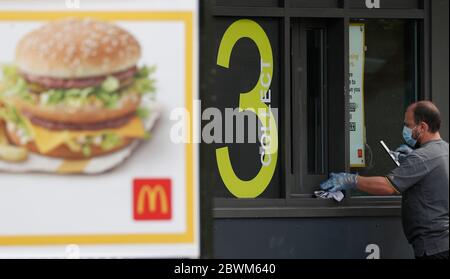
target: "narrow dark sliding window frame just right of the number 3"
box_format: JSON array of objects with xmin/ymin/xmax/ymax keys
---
[{"xmin": 291, "ymin": 19, "xmax": 329, "ymax": 197}]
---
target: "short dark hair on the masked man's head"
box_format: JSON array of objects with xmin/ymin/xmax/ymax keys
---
[{"xmin": 412, "ymin": 101, "xmax": 441, "ymax": 133}]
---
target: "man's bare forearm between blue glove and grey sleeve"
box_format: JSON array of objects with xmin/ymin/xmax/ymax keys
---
[{"xmin": 356, "ymin": 176, "xmax": 399, "ymax": 196}]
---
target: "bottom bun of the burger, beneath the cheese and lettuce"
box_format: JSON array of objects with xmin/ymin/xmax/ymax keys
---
[{"xmin": 5, "ymin": 129, "xmax": 133, "ymax": 160}]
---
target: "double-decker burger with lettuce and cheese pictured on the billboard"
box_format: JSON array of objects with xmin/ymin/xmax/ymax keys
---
[{"xmin": 0, "ymin": 18, "xmax": 154, "ymax": 159}]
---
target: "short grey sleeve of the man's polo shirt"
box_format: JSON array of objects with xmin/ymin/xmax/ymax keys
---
[{"xmin": 386, "ymin": 153, "xmax": 429, "ymax": 193}]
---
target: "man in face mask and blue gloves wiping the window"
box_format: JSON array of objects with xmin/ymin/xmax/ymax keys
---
[{"xmin": 320, "ymin": 101, "xmax": 449, "ymax": 259}]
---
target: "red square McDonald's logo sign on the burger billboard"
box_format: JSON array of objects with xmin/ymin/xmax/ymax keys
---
[{"xmin": 133, "ymin": 179, "xmax": 172, "ymax": 220}]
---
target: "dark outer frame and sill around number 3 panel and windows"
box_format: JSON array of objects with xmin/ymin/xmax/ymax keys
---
[{"xmin": 200, "ymin": 0, "xmax": 431, "ymax": 218}]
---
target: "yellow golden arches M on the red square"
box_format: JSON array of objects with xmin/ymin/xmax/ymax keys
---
[{"xmin": 137, "ymin": 184, "xmax": 169, "ymax": 214}]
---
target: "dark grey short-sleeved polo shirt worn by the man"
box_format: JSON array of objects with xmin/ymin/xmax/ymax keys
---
[{"xmin": 387, "ymin": 140, "xmax": 449, "ymax": 256}]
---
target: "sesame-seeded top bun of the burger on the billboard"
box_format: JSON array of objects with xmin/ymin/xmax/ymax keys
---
[{"xmin": 16, "ymin": 18, "xmax": 141, "ymax": 79}]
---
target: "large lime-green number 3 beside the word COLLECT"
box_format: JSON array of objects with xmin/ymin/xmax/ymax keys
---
[{"xmin": 216, "ymin": 19, "xmax": 278, "ymax": 198}]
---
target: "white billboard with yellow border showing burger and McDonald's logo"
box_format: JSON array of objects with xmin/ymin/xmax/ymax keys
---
[{"xmin": 0, "ymin": 0, "xmax": 199, "ymax": 258}]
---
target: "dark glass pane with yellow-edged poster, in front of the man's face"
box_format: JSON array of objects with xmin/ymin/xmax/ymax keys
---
[{"xmin": 349, "ymin": 20, "xmax": 418, "ymax": 196}]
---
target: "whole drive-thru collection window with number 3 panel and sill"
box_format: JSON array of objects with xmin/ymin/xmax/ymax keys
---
[{"xmin": 201, "ymin": 0, "xmax": 442, "ymax": 217}]
